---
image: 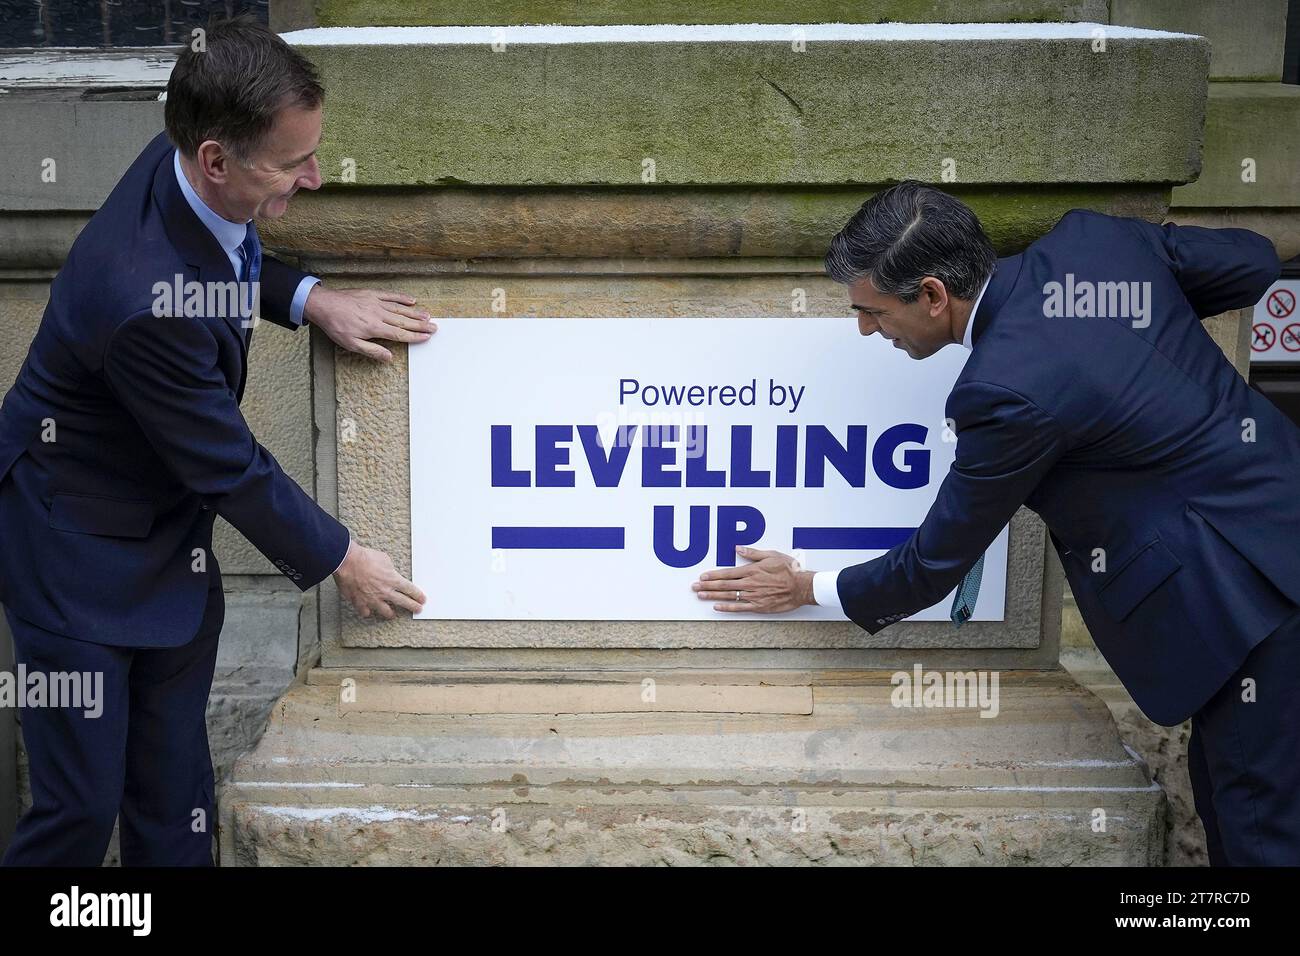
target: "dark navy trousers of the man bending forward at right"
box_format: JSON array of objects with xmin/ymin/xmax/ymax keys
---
[{"xmin": 1187, "ymin": 610, "xmax": 1300, "ymax": 866}]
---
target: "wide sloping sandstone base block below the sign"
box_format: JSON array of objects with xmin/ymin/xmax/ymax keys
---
[{"xmin": 221, "ymin": 670, "xmax": 1164, "ymax": 865}]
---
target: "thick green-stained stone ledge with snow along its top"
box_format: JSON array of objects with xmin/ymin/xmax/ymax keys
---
[{"xmin": 285, "ymin": 23, "xmax": 1209, "ymax": 187}]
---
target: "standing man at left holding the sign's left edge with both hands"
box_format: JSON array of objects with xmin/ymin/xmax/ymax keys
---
[{"xmin": 0, "ymin": 20, "xmax": 434, "ymax": 866}]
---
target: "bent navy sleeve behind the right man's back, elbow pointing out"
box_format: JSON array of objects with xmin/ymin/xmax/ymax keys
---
[{"xmin": 1126, "ymin": 219, "xmax": 1282, "ymax": 319}]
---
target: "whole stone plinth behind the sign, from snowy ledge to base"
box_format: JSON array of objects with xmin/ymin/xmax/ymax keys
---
[{"xmin": 221, "ymin": 18, "xmax": 1209, "ymax": 865}]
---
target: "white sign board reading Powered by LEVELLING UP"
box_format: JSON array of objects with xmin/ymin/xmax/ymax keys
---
[{"xmin": 410, "ymin": 317, "xmax": 1008, "ymax": 620}]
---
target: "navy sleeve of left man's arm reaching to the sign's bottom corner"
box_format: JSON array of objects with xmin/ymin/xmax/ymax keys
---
[{"xmin": 104, "ymin": 312, "xmax": 348, "ymax": 591}]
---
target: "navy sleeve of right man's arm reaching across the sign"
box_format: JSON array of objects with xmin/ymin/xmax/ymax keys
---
[{"xmin": 836, "ymin": 382, "xmax": 1067, "ymax": 633}]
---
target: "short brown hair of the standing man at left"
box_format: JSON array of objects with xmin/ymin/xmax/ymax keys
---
[{"xmin": 164, "ymin": 14, "xmax": 325, "ymax": 163}]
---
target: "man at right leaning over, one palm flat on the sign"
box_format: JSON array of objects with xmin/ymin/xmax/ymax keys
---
[{"xmin": 693, "ymin": 182, "xmax": 1300, "ymax": 865}]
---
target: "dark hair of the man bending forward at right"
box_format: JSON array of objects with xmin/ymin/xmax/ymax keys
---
[{"xmin": 826, "ymin": 179, "xmax": 997, "ymax": 302}]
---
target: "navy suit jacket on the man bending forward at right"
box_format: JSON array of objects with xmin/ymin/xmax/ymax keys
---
[{"xmin": 837, "ymin": 209, "xmax": 1300, "ymax": 726}]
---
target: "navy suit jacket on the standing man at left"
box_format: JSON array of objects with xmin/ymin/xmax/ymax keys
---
[{"xmin": 0, "ymin": 135, "xmax": 348, "ymax": 648}]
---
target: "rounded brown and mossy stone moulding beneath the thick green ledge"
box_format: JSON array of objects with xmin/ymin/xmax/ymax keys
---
[{"xmin": 263, "ymin": 185, "xmax": 1169, "ymax": 260}]
